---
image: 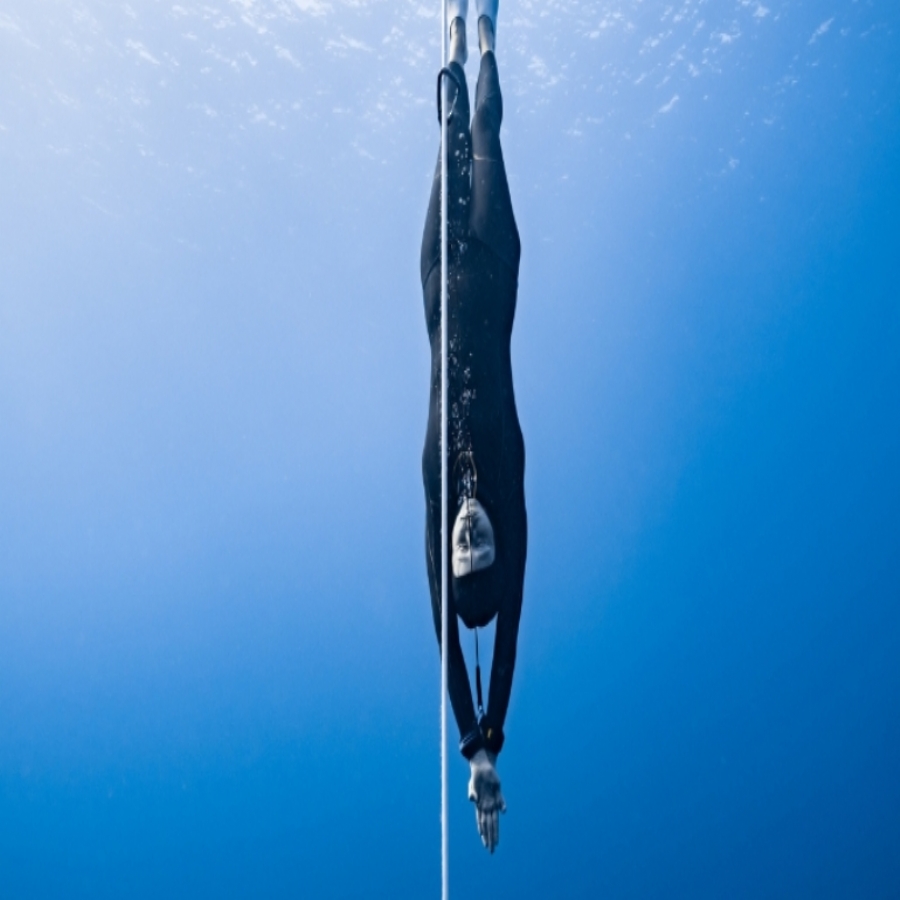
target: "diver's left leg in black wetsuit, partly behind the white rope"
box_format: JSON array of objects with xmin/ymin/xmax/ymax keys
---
[{"xmin": 421, "ymin": 62, "xmax": 472, "ymax": 287}]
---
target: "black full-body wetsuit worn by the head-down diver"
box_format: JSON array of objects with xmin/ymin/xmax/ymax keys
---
[{"xmin": 421, "ymin": 52, "xmax": 527, "ymax": 759}]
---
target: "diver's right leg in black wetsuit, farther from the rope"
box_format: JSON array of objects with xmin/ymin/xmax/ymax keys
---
[{"xmin": 470, "ymin": 50, "xmax": 521, "ymax": 270}]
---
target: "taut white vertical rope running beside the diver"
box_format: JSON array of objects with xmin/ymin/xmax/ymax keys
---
[{"xmin": 441, "ymin": 0, "xmax": 450, "ymax": 900}]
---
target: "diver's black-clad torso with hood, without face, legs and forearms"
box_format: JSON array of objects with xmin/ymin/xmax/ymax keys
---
[{"xmin": 422, "ymin": 240, "xmax": 526, "ymax": 628}]
